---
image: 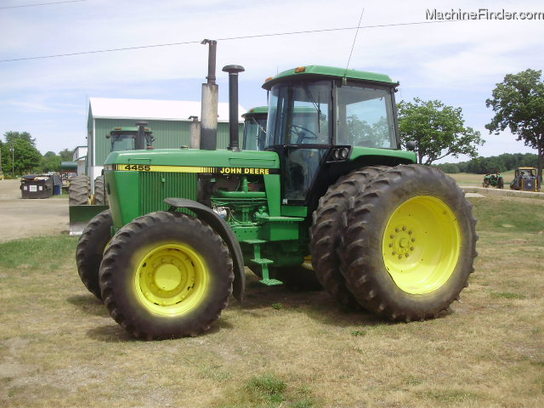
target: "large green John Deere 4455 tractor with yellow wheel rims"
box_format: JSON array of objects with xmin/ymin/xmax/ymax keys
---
[{"xmin": 77, "ymin": 65, "xmax": 477, "ymax": 339}]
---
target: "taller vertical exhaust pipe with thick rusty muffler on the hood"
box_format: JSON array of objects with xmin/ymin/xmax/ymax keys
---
[{"xmin": 200, "ymin": 39, "xmax": 218, "ymax": 150}]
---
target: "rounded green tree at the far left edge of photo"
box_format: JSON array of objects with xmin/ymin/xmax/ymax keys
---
[{"xmin": 2, "ymin": 131, "xmax": 42, "ymax": 174}]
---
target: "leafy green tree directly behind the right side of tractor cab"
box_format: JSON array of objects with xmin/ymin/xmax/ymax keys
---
[{"xmin": 398, "ymin": 98, "xmax": 484, "ymax": 165}]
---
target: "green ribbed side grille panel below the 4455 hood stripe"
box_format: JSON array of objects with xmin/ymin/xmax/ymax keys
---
[{"xmin": 140, "ymin": 172, "xmax": 197, "ymax": 214}]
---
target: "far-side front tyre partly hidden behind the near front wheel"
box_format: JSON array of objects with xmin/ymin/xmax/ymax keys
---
[{"xmin": 76, "ymin": 210, "xmax": 113, "ymax": 299}]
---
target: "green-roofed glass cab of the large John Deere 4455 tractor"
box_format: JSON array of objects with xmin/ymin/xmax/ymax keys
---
[{"xmin": 263, "ymin": 65, "xmax": 406, "ymax": 206}]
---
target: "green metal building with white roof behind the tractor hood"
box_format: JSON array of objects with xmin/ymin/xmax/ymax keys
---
[{"xmin": 87, "ymin": 98, "xmax": 246, "ymax": 180}]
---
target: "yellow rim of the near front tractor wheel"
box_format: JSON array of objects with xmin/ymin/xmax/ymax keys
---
[{"xmin": 134, "ymin": 243, "xmax": 210, "ymax": 316}]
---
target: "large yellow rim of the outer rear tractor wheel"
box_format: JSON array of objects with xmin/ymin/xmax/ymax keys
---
[{"xmin": 382, "ymin": 196, "xmax": 461, "ymax": 295}]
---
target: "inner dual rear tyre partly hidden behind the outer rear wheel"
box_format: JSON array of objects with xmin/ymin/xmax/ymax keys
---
[{"xmin": 310, "ymin": 166, "xmax": 389, "ymax": 308}]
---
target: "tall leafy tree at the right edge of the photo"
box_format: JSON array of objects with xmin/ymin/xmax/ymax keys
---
[{"xmin": 485, "ymin": 69, "xmax": 544, "ymax": 184}]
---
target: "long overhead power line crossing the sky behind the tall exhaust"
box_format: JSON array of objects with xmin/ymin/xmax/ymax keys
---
[{"xmin": 0, "ymin": 20, "xmax": 458, "ymax": 63}]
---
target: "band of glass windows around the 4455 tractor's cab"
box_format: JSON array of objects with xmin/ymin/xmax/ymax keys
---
[{"xmin": 265, "ymin": 80, "xmax": 398, "ymax": 149}]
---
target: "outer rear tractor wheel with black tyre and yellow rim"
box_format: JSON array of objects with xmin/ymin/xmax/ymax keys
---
[{"xmin": 342, "ymin": 165, "xmax": 477, "ymax": 321}]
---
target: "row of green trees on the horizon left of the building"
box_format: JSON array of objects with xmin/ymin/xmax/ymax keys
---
[{"xmin": 0, "ymin": 131, "xmax": 73, "ymax": 176}]
